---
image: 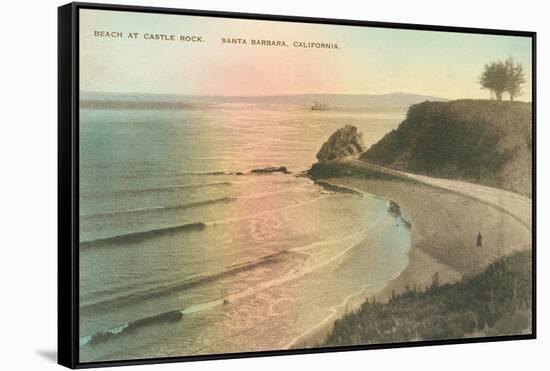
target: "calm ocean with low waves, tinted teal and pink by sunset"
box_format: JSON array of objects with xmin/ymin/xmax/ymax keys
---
[{"xmin": 79, "ymin": 103, "xmax": 410, "ymax": 362}]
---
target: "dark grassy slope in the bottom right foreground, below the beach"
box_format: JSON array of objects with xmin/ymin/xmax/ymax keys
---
[{"xmin": 320, "ymin": 252, "xmax": 532, "ymax": 346}]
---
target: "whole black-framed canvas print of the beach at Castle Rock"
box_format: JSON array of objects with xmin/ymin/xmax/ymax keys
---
[{"xmin": 58, "ymin": 3, "xmax": 536, "ymax": 368}]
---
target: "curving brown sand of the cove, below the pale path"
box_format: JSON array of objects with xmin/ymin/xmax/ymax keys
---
[{"xmin": 289, "ymin": 169, "xmax": 531, "ymax": 349}]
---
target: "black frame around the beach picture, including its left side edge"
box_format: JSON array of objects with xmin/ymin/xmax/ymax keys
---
[{"xmin": 58, "ymin": 3, "xmax": 537, "ymax": 368}]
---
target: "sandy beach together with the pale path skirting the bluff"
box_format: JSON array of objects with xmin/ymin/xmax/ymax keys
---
[{"xmin": 292, "ymin": 160, "xmax": 531, "ymax": 348}]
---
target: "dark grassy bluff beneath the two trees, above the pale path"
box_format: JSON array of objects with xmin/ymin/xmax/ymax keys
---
[{"xmin": 361, "ymin": 100, "xmax": 532, "ymax": 195}]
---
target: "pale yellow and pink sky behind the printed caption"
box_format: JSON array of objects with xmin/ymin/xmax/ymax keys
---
[{"xmin": 80, "ymin": 9, "xmax": 532, "ymax": 101}]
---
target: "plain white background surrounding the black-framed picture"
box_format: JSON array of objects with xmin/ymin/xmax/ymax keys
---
[{"xmin": 0, "ymin": 0, "xmax": 550, "ymax": 371}]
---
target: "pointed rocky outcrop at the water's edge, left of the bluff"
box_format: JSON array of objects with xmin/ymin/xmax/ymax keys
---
[{"xmin": 316, "ymin": 125, "xmax": 365, "ymax": 162}]
